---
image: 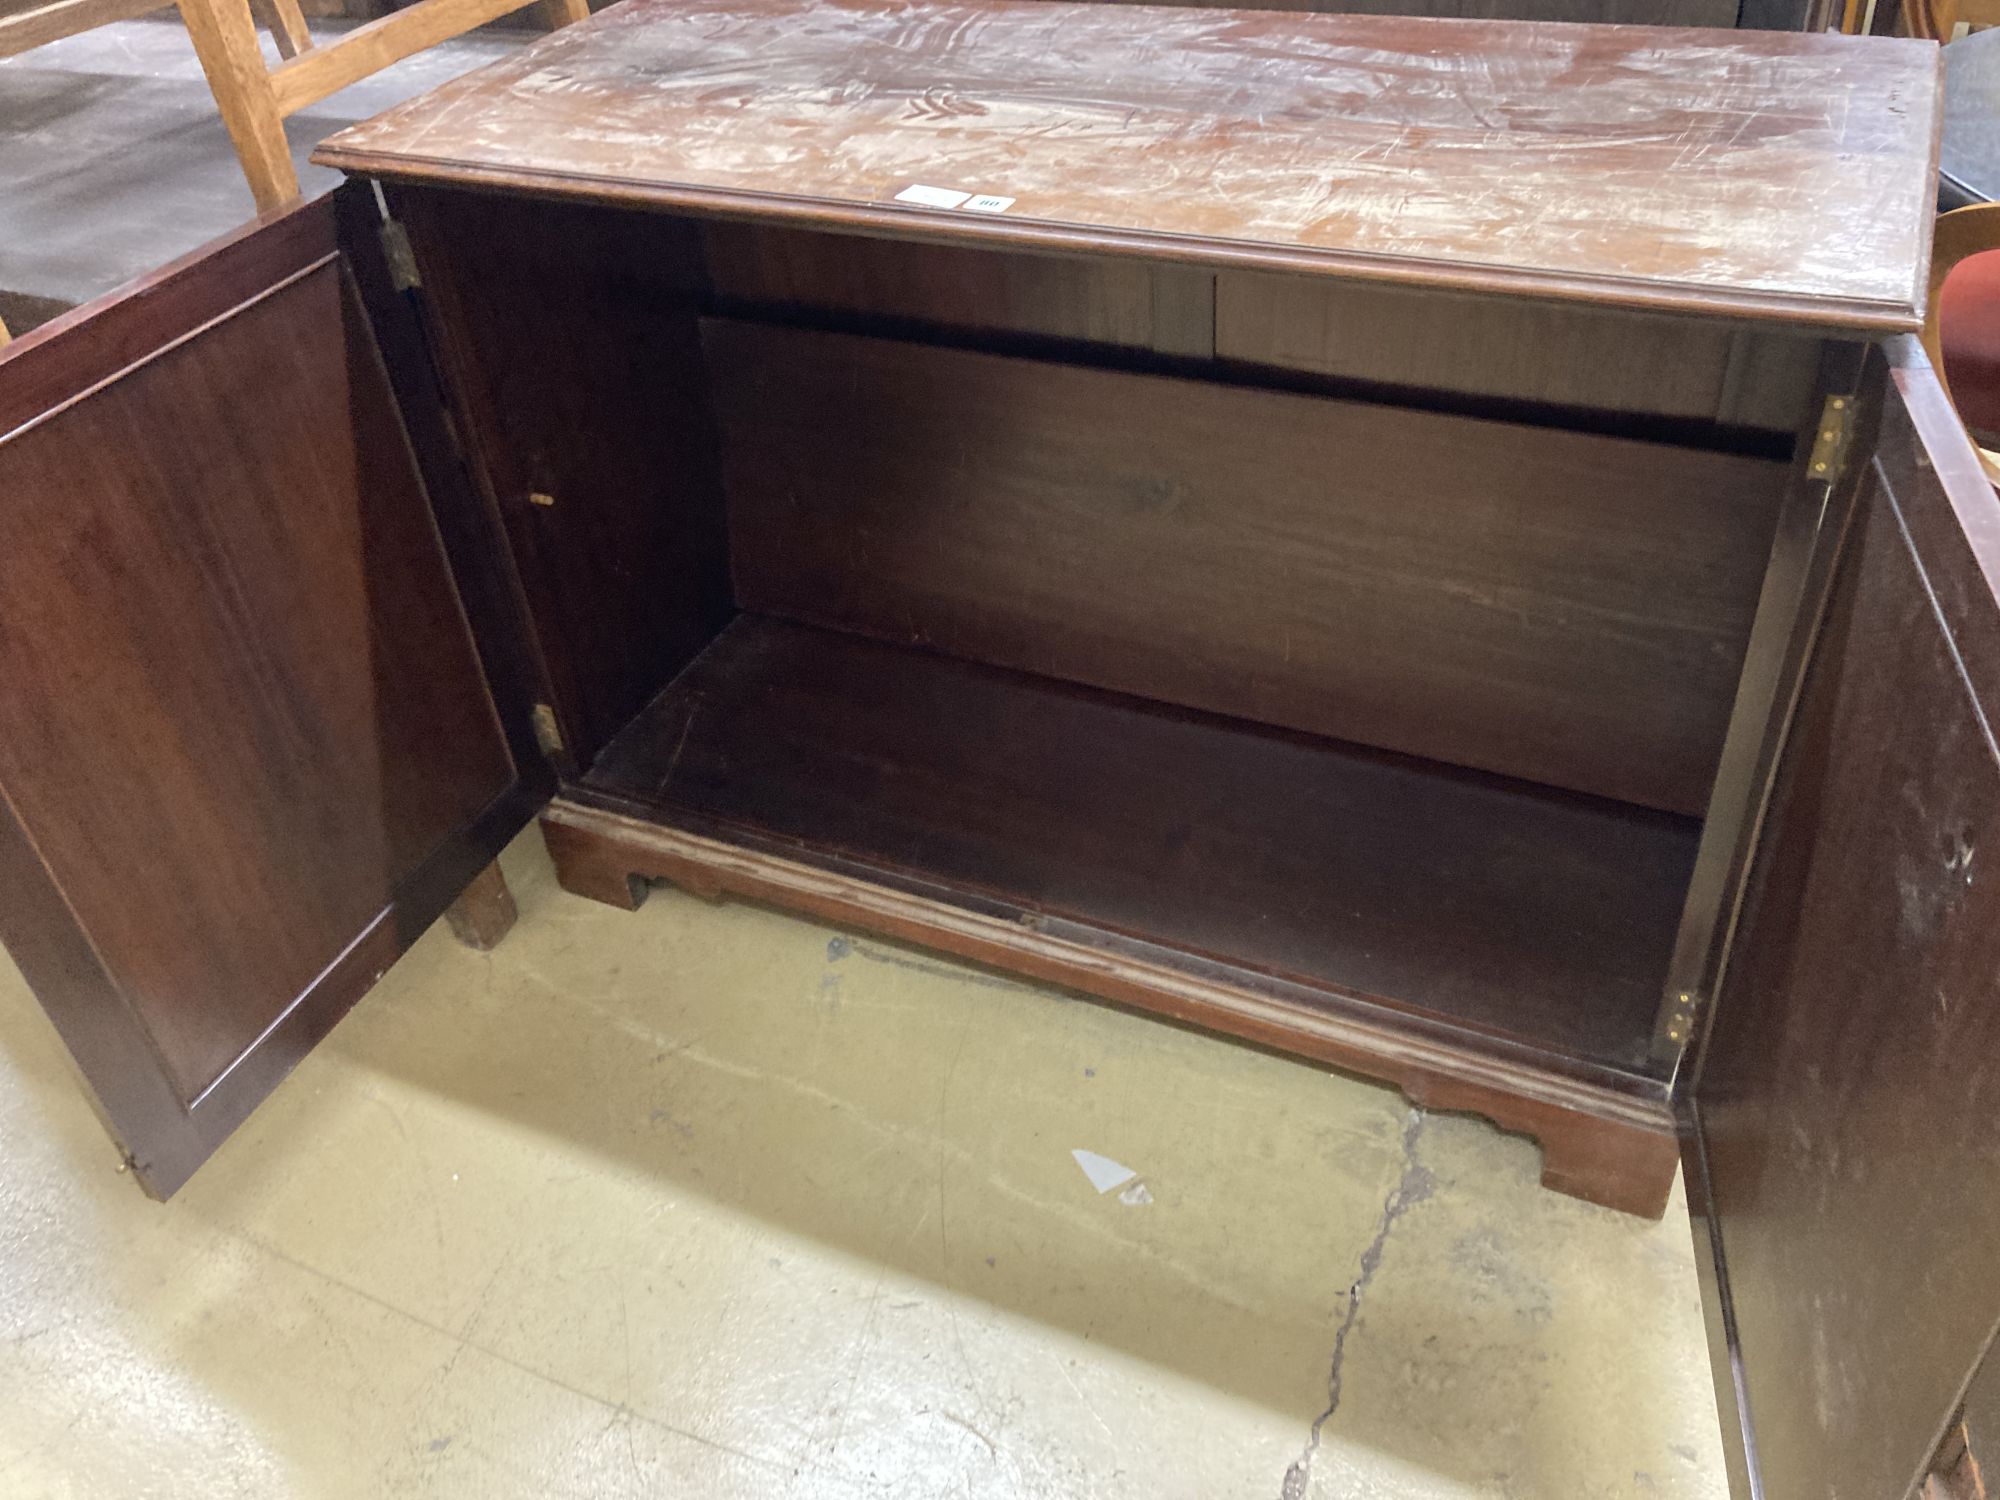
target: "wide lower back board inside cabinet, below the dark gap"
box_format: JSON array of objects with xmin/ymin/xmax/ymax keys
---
[{"xmin": 702, "ymin": 320, "xmax": 1786, "ymax": 814}]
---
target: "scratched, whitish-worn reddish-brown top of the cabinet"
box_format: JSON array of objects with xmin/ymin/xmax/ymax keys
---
[{"xmin": 316, "ymin": 0, "xmax": 1940, "ymax": 330}]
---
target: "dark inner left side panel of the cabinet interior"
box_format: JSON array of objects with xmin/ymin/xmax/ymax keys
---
[{"xmin": 392, "ymin": 190, "xmax": 732, "ymax": 764}]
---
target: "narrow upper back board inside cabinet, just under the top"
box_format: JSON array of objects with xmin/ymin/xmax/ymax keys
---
[{"xmin": 702, "ymin": 220, "xmax": 1820, "ymax": 442}]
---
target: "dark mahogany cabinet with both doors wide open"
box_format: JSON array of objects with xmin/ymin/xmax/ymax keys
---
[{"xmin": 0, "ymin": 0, "xmax": 2000, "ymax": 1500}]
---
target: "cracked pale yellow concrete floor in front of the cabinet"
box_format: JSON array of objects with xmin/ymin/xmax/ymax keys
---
[{"xmin": 0, "ymin": 834, "xmax": 1724, "ymax": 1500}]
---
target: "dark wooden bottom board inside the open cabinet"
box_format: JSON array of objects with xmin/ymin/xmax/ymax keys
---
[{"xmin": 582, "ymin": 614, "xmax": 1696, "ymax": 1078}]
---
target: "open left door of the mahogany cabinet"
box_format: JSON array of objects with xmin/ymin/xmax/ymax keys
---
[{"xmin": 0, "ymin": 196, "xmax": 540, "ymax": 1196}]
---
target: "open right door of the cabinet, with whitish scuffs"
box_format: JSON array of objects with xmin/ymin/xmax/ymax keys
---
[{"xmin": 1684, "ymin": 338, "xmax": 2000, "ymax": 1500}]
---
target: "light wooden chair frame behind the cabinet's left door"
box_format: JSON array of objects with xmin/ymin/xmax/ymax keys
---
[{"xmin": 0, "ymin": 0, "xmax": 590, "ymax": 214}]
